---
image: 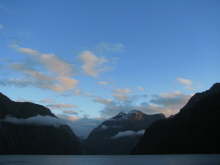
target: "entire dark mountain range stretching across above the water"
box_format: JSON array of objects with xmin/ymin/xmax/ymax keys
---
[{"xmin": 0, "ymin": 83, "xmax": 220, "ymax": 155}]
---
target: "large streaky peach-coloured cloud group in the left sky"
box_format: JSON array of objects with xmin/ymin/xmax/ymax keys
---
[{"xmin": 6, "ymin": 44, "xmax": 79, "ymax": 92}]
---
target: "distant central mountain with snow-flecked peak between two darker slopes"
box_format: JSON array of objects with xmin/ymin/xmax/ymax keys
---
[{"xmin": 84, "ymin": 110, "xmax": 165, "ymax": 154}]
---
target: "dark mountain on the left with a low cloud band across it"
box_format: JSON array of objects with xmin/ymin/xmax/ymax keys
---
[{"xmin": 0, "ymin": 93, "xmax": 81, "ymax": 154}]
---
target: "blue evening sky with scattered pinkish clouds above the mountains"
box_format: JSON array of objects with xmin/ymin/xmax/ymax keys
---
[{"xmin": 0, "ymin": 0, "xmax": 220, "ymax": 137}]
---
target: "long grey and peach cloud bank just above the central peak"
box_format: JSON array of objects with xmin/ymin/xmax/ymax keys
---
[{"xmin": 99, "ymin": 91, "xmax": 191, "ymax": 118}]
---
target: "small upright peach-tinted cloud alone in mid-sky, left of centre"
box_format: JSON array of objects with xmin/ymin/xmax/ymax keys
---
[{"xmin": 79, "ymin": 51, "xmax": 108, "ymax": 77}]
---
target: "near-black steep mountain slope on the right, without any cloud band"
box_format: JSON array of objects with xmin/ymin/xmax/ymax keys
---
[{"xmin": 133, "ymin": 83, "xmax": 220, "ymax": 154}]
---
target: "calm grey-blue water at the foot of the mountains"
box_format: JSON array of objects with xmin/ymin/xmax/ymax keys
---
[{"xmin": 0, "ymin": 155, "xmax": 220, "ymax": 165}]
